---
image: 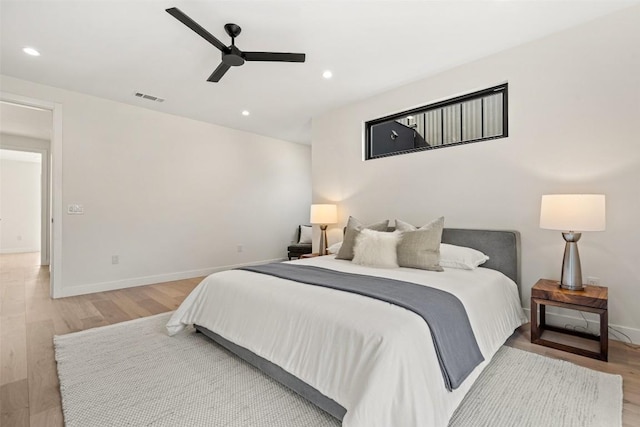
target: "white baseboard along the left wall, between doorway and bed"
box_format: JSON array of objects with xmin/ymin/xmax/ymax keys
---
[{"xmin": 55, "ymin": 258, "xmax": 284, "ymax": 298}]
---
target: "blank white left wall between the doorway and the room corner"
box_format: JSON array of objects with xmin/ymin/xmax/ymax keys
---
[{"xmin": 0, "ymin": 76, "xmax": 311, "ymax": 296}]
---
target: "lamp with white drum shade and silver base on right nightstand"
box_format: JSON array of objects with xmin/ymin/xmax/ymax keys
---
[{"xmin": 540, "ymin": 194, "xmax": 605, "ymax": 291}]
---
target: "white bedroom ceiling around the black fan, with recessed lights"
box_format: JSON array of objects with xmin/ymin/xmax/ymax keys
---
[{"xmin": 0, "ymin": 0, "xmax": 638, "ymax": 143}]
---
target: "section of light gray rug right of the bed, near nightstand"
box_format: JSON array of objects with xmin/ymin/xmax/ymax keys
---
[{"xmin": 449, "ymin": 346, "xmax": 622, "ymax": 427}]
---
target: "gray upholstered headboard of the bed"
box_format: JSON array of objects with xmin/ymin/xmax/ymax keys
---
[{"xmin": 442, "ymin": 228, "xmax": 520, "ymax": 288}]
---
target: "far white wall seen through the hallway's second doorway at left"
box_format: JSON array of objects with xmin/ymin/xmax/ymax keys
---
[{"xmin": 0, "ymin": 159, "xmax": 42, "ymax": 253}]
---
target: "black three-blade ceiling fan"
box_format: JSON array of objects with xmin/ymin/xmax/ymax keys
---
[{"xmin": 166, "ymin": 7, "xmax": 305, "ymax": 82}]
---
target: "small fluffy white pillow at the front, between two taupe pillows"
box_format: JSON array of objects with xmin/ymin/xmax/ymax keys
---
[{"xmin": 353, "ymin": 229, "xmax": 400, "ymax": 268}]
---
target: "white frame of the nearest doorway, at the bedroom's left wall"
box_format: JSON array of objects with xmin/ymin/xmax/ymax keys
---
[{"xmin": 0, "ymin": 91, "xmax": 63, "ymax": 298}]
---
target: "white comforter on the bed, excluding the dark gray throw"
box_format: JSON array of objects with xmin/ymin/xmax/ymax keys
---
[{"xmin": 167, "ymin": 256, "xmax": 526, "ymax": 427}]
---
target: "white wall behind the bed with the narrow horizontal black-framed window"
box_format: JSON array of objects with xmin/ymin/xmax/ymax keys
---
[{"xmin": 312, "ymin": 7, "xmax": 640, "ymax": 341}]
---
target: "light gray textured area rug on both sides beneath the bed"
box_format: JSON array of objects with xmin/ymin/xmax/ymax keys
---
[{"xmin": 54, "ymin": 313, "xmax": 622, "ymax": 427}]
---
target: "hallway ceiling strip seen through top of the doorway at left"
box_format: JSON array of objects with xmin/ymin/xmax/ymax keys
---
[{"xmin": 0, "ymin": 101, "xmax": 53, "ymax": 140}]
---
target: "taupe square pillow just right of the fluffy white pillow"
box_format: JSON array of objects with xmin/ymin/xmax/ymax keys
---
[{"xmin": 396, "ymin": 217, "xmax": 444, "ymax": 271}]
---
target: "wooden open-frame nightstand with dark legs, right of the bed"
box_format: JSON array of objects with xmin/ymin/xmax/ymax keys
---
[{"xmin": 531, "ymin": 279, "xmax": 609, "ymax": 361}]
